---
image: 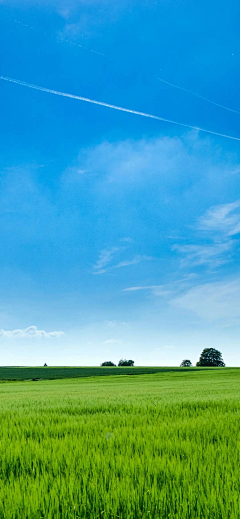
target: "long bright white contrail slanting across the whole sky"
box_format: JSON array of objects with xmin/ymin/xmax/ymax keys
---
[{"xmin": 0, "ymin": 76, "xmax": 240, "ymax": 141}]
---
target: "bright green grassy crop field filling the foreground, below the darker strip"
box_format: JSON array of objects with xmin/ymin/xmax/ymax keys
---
[{"xmin": 0, "ymin": 368, "xmax": 240, "ymax": 519}]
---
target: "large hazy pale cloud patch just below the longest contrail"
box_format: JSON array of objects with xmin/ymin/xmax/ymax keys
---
[{"xmin": 79, "ymin": 132, "xmax": 239, "ymax": 190}]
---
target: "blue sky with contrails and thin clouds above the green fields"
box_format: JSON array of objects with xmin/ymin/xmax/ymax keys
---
[{"xmin": 0, "ymin": 0, "xmax": 240, "ymax": 366}]
